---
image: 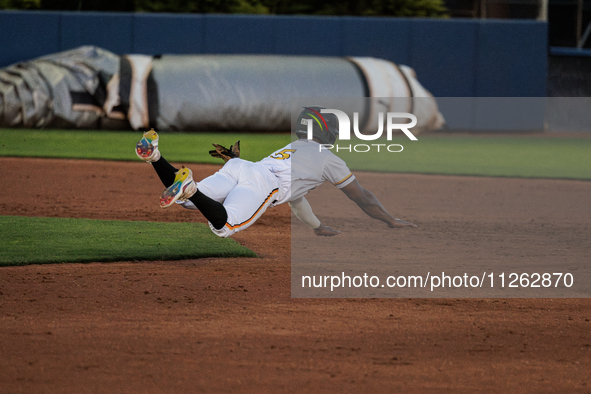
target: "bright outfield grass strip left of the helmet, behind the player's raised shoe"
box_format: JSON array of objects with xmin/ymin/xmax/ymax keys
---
[{"xmin": 0, "ymin": 129, "xmax": 290, "ymax": 164}]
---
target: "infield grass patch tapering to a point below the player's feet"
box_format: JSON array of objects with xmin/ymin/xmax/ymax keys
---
[{"xmin": 0, "ymin": 216, "xmax": 256, "ymax": 266}]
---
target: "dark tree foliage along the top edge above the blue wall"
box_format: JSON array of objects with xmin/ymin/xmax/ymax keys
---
[{"xmin": 0, "ymin": 0, "xmax": 447, "ymax": 17}]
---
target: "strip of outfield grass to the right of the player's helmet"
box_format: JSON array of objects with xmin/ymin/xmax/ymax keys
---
[{"xmin": 333, "ymin": 135, "xmax": 591, "ymax": 179}]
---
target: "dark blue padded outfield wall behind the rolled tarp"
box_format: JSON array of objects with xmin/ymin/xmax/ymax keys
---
[{"xmin": 0, "ymin": 11, "xmax": 548, "ymax": 97}]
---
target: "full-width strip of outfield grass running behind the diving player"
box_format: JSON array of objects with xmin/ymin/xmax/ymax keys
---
[{"xmin": 0, "ymin": 129, "xmax": 591, "ymax": 179}]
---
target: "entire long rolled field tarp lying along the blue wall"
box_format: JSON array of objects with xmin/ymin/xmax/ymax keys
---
[{"xmin": 0, "ymin": 46, "xmax": 444, "ymax": 131}]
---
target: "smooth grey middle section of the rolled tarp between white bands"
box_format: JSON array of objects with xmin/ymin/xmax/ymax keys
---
[{"xmin": 153, "ymin": 55, "xmax": 365, "ymax": 130}]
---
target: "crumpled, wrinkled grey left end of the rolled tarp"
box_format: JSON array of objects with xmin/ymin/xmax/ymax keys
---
[{"xmin": 0, "ymin": 47, "xmax": 119, "ymax": 128}]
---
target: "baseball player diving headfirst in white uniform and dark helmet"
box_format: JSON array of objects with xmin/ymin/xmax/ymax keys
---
[{"xmin": 136, "ymin": 107, "xmax": 416, "ymax": 237}]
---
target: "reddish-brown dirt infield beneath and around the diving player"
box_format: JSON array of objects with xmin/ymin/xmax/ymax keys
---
[{"xmin": 0, "ymin": 158, "xmax": 591, "ymax": 393}]
